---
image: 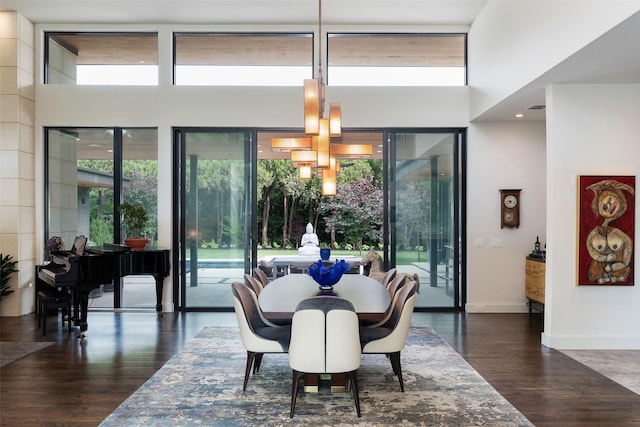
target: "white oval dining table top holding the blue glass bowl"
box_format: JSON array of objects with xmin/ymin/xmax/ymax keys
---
[{"xmin": 258, "ymin": 274, "xmax": 391, "ymax": 318}]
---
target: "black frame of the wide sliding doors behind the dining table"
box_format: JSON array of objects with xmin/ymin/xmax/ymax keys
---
[{"xmin": 172, "ymin": 127, "xmax": 467, "ymax": 311}]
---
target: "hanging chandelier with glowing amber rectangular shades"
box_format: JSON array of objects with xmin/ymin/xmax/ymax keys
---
[{"xmin": 271, "ymin": 0, "xmax": 373, "ymax": 196}]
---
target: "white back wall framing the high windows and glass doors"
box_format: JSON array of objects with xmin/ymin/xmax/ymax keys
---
[{"xmin": 27, "ymin": 25, "xmax": 469, "ymax": 314}]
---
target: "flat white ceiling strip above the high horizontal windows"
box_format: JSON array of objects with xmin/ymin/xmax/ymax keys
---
[{"xmin": 2, "ymin": 0, "xmax": 486, "ymax": 25}]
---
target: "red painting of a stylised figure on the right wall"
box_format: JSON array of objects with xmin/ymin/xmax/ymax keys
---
[{"xmin": 578, "ymin": 175, "xmax": 636, "ymax": 286}]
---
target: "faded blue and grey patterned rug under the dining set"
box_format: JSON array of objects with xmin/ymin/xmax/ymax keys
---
[{"xmin": 100, "ymin": 327, "xmax": 533, "ymax": 427}]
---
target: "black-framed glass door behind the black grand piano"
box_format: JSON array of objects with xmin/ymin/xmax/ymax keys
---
[{"xmin": 45, "ymin": 127, "xmax": 158, "ymax": 309}]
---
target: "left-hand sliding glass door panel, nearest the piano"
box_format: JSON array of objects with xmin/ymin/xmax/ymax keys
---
[{"xmin": 174, "ymin": 129, "xmax": 254, "ymax": 310}]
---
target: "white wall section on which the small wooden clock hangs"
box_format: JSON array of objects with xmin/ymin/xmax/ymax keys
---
[{"xmin": 466, "ymin": 122, "xmax": 546, "ymax": 312}]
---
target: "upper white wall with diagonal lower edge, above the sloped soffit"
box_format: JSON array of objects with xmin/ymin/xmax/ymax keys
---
[{"xmin": 468, "ymin": 0, "xmax": 640, "ymax": 120}]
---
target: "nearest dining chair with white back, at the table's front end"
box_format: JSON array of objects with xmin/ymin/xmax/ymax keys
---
[{"xmin": 289, "ymin": 296, "xmax": 361, "ymax": 417}]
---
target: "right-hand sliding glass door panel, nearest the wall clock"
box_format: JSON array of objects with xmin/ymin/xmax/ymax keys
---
[{"xmin": 385, "ymin": 131, "xmax": 464, "ymax": 309}]
